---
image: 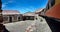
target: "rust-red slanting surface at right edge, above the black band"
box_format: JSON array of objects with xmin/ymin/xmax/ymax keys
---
[{"xmin": 45, "ymin": 4, "xmax": 60, "ymax": 19}]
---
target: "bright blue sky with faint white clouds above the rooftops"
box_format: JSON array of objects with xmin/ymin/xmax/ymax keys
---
[{"xmin": 2, "ymin": 0, "xmax": 48, "ymax": 14}]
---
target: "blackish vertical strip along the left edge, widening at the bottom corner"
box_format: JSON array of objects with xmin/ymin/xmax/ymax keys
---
[{"xmin": 0, "ymin": 0, "xmax": 9, "ymax": 32}]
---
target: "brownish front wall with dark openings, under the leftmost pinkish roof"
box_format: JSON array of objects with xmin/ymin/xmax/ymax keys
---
[{"xmin": 3, "ymin": 14, "xmax": 22, "ymax": 23}]
